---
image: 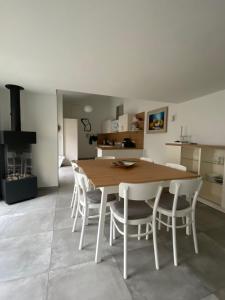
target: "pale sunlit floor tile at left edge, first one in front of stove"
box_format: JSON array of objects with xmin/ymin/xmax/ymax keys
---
[{"xmin": 0, "ymin": 210, "xmax": 54, "ymax": 239}]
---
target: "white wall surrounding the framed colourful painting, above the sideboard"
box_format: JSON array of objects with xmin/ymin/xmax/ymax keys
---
[{"xmin": 115, "ymin": 90, "xmax": 225, "ymax": 163}]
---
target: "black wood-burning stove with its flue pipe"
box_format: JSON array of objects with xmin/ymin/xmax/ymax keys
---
[{"xmin": 0, "ymin": 84, "xmax": 37, "ymax": 204}]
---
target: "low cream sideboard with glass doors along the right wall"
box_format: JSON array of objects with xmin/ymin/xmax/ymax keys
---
[{"xmin": 167, "ymin": 143, "xmax": 225, "ymax": 211}]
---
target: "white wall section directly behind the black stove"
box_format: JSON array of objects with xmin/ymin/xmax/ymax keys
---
[{"xmin": 0, "ymin": 89, "xmax": 58, "ymax": 187}]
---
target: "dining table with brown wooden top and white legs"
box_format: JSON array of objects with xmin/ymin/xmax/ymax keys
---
[{"xmin": 77, "ymin": 159, "xmax": 198, "ymax": 263}]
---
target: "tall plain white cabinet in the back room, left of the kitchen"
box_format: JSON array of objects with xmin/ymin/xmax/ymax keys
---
[{"xmin": 63, "ymin": 119, "xmax": 78, "ymax": 164}]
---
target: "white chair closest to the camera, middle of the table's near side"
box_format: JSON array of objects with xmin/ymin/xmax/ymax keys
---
[{"xmin": 110, "ymin": 183, "xmax": 162, "ymax": 279}]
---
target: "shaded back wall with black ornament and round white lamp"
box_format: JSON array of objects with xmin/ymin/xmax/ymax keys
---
[{"xmin": 63, "ymin": 95, "xmax": 116, "ymax": 158}]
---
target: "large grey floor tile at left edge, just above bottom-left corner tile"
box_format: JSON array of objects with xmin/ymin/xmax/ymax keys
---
[{"xmin": 0, "ymin": 232, "xmax": 52, "ymax": 281}]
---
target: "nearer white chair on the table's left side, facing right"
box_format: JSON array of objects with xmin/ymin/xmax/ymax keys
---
[{"xmin": 72, "ymin": 168, "xmax": 116, "ymax": 250}]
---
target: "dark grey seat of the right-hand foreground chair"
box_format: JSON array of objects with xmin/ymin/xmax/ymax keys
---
[{"xmin": 158, "ymin": 189, "xmax": 190, "ymax": 210}]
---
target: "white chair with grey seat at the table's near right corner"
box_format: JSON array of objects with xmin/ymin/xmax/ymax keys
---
[{"xmin": 152, "ymin": 178, "xmax": 202, "ymax": 266}]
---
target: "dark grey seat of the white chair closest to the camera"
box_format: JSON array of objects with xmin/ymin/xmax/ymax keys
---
[{"xmin": 110, "ymin": 199, "xmax": 152, "ymax": 220}]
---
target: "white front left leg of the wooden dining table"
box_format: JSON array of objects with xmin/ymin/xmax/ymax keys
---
[{"xmin": 95, "ymin": 188, "xmax": 108, "ymax": 264}]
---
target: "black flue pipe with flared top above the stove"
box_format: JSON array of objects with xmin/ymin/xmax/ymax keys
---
[{"xmin": 5, "ymin": 84, "xmax": 24, "ymax": 131}]
